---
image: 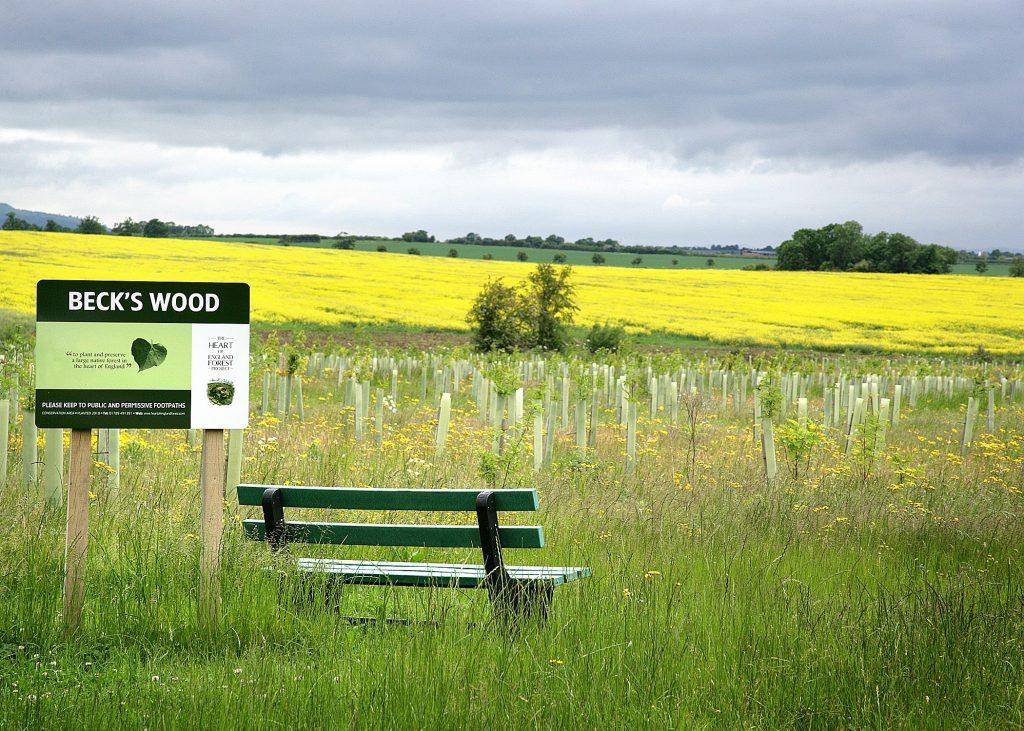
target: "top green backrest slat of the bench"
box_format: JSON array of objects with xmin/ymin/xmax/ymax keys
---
[{"xmin": 238, "ymin": 484, "xmax": 540, "ymax": 512}]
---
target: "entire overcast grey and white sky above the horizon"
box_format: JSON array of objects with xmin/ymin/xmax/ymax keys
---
[{"xmin": 0, "ymin": 0, "xmax": 1024, "ymax": 248}]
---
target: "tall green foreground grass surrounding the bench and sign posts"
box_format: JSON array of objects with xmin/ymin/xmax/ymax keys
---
[{"xmin": 0, "ymin": 346, "xmax": 1024, "ymax": 729}]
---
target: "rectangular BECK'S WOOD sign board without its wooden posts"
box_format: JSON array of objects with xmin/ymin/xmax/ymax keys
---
[{"xmin": 36, "ymin": 280, "xmax": 249, "ymax": 429}]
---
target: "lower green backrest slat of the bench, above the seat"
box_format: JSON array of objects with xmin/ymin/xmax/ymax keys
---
[{"xmin": 242, "ymin": 520, "xmax": 544, "ymax": 549}]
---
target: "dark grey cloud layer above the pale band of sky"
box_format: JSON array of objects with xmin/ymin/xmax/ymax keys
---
[{"xmin": 0, "ymin": 0, "xmax": 1024, "ymax": 166}]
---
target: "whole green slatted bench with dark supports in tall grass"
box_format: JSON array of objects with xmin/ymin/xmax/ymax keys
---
[{"xmin": 238, "ymin": 484, "xmax": 590, "ymax": 617}]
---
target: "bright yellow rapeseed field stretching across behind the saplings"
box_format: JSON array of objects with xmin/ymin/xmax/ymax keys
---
[{"xmin": 0, "ymin": 231, "xmax": 1024, "ymax": 353}]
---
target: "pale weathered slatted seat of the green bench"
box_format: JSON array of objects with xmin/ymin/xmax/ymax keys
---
[{"xmin": 298, "ymin": 558, "xmax": 590, "ymax": 589}]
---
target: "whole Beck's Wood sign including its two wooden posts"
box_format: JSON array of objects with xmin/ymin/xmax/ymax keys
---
[{"xmin": 31, "ymin": 280, "xmax": 249, "ymax": 631}]
